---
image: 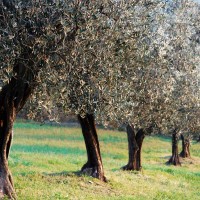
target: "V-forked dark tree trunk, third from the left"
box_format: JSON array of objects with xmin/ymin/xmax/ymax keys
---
[{"xmin": 122, "ymin": 125, "xmax": 145, "ymax": 171}]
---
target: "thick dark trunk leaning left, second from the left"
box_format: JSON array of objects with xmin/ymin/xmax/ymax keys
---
[{"xmin": 78, "ymin": 114, "xmax": 106, "ymax": 181}]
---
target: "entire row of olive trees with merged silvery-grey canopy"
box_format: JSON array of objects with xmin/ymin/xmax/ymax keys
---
[{"xmin": 0, "ymin": 0, "xmax": 200, "ymax": 199}]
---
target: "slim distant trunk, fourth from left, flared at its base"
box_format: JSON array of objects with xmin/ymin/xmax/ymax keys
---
[{"xmin": 167, "ymin": 130, "xmax": 181, "ymax": 166}]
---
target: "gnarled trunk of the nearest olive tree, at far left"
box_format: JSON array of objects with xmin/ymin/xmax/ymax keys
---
[{"xmin": 0, "ymin": 58, "xmax": 35, "ymax": 199}]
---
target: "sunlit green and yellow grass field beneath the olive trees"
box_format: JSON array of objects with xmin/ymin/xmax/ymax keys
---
[{"xmin": 9, "ymin": 123, "xmax": 200, "ymax": 200}]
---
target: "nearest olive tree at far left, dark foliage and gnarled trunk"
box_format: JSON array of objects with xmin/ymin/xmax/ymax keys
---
[{"xmin": 0, "ymin": 0, "xmax": 85, "ymax": 199}]
